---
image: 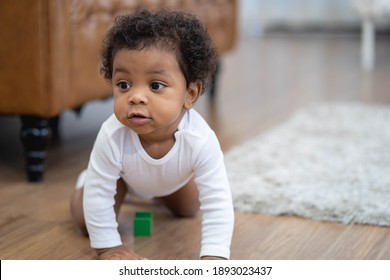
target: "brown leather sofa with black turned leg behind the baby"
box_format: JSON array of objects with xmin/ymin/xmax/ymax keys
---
[{"xmin": 0, "ymin": 0, "xmax": 237, "ymax": 182}]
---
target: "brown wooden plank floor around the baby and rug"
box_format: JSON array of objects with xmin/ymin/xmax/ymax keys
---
[{"xmin": 0, "ymin": 31, "xmax": 390, "ymax": 259}]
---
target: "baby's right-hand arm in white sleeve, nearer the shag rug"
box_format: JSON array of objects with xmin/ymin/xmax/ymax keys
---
[{"xmin": 195, "ymin": 132, "xmax": 234, "ymax": 259}]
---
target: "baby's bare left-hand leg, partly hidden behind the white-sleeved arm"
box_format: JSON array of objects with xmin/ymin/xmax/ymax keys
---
[{"xmin": 70, "ymin": 179, "xmax": 127, "ymax": 235}]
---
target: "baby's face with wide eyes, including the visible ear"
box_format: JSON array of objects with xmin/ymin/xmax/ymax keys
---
[{"xmin": 112, "ymin": 48, "xmax": 199, "ymax": 141}]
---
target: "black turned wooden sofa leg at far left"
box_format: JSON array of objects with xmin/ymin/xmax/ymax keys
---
[{"xmin": 20, "ymin": 116, "xmax": 51, "ymax": 182}]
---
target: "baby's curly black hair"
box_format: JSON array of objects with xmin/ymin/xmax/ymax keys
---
[{"xmin": 101, "ymin": 10, "xmax": 218, "ymax": 91}]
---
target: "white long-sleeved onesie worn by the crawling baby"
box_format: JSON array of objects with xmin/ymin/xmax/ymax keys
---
[{"xmin": 83, "ymin": 109, "xmax": 234, "ymax": 258}]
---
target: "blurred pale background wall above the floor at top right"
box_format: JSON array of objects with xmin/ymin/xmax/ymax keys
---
[{"xmin": 240, "ymin": 0, "xmax": 390, "ymax": 36}]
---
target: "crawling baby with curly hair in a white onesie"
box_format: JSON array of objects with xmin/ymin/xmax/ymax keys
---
[{"xmin": 71, "ymin": 10, "xmax": 234, "ymax": 259}]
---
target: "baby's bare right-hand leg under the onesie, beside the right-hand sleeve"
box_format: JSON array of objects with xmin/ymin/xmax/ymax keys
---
[{"xmin": 159, "ymin": 178, "xmax": 200, "ymax": 217}]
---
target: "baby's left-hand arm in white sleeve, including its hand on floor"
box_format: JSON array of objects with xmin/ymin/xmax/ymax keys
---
[{"xmin": 83, "ymin": 118, "xmax": 143, "ymax": 260}]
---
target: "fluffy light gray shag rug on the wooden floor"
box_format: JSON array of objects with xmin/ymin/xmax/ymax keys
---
[{"xmin": 225, "ymin": 103, "xmax": 390, "ymax": 226}]
